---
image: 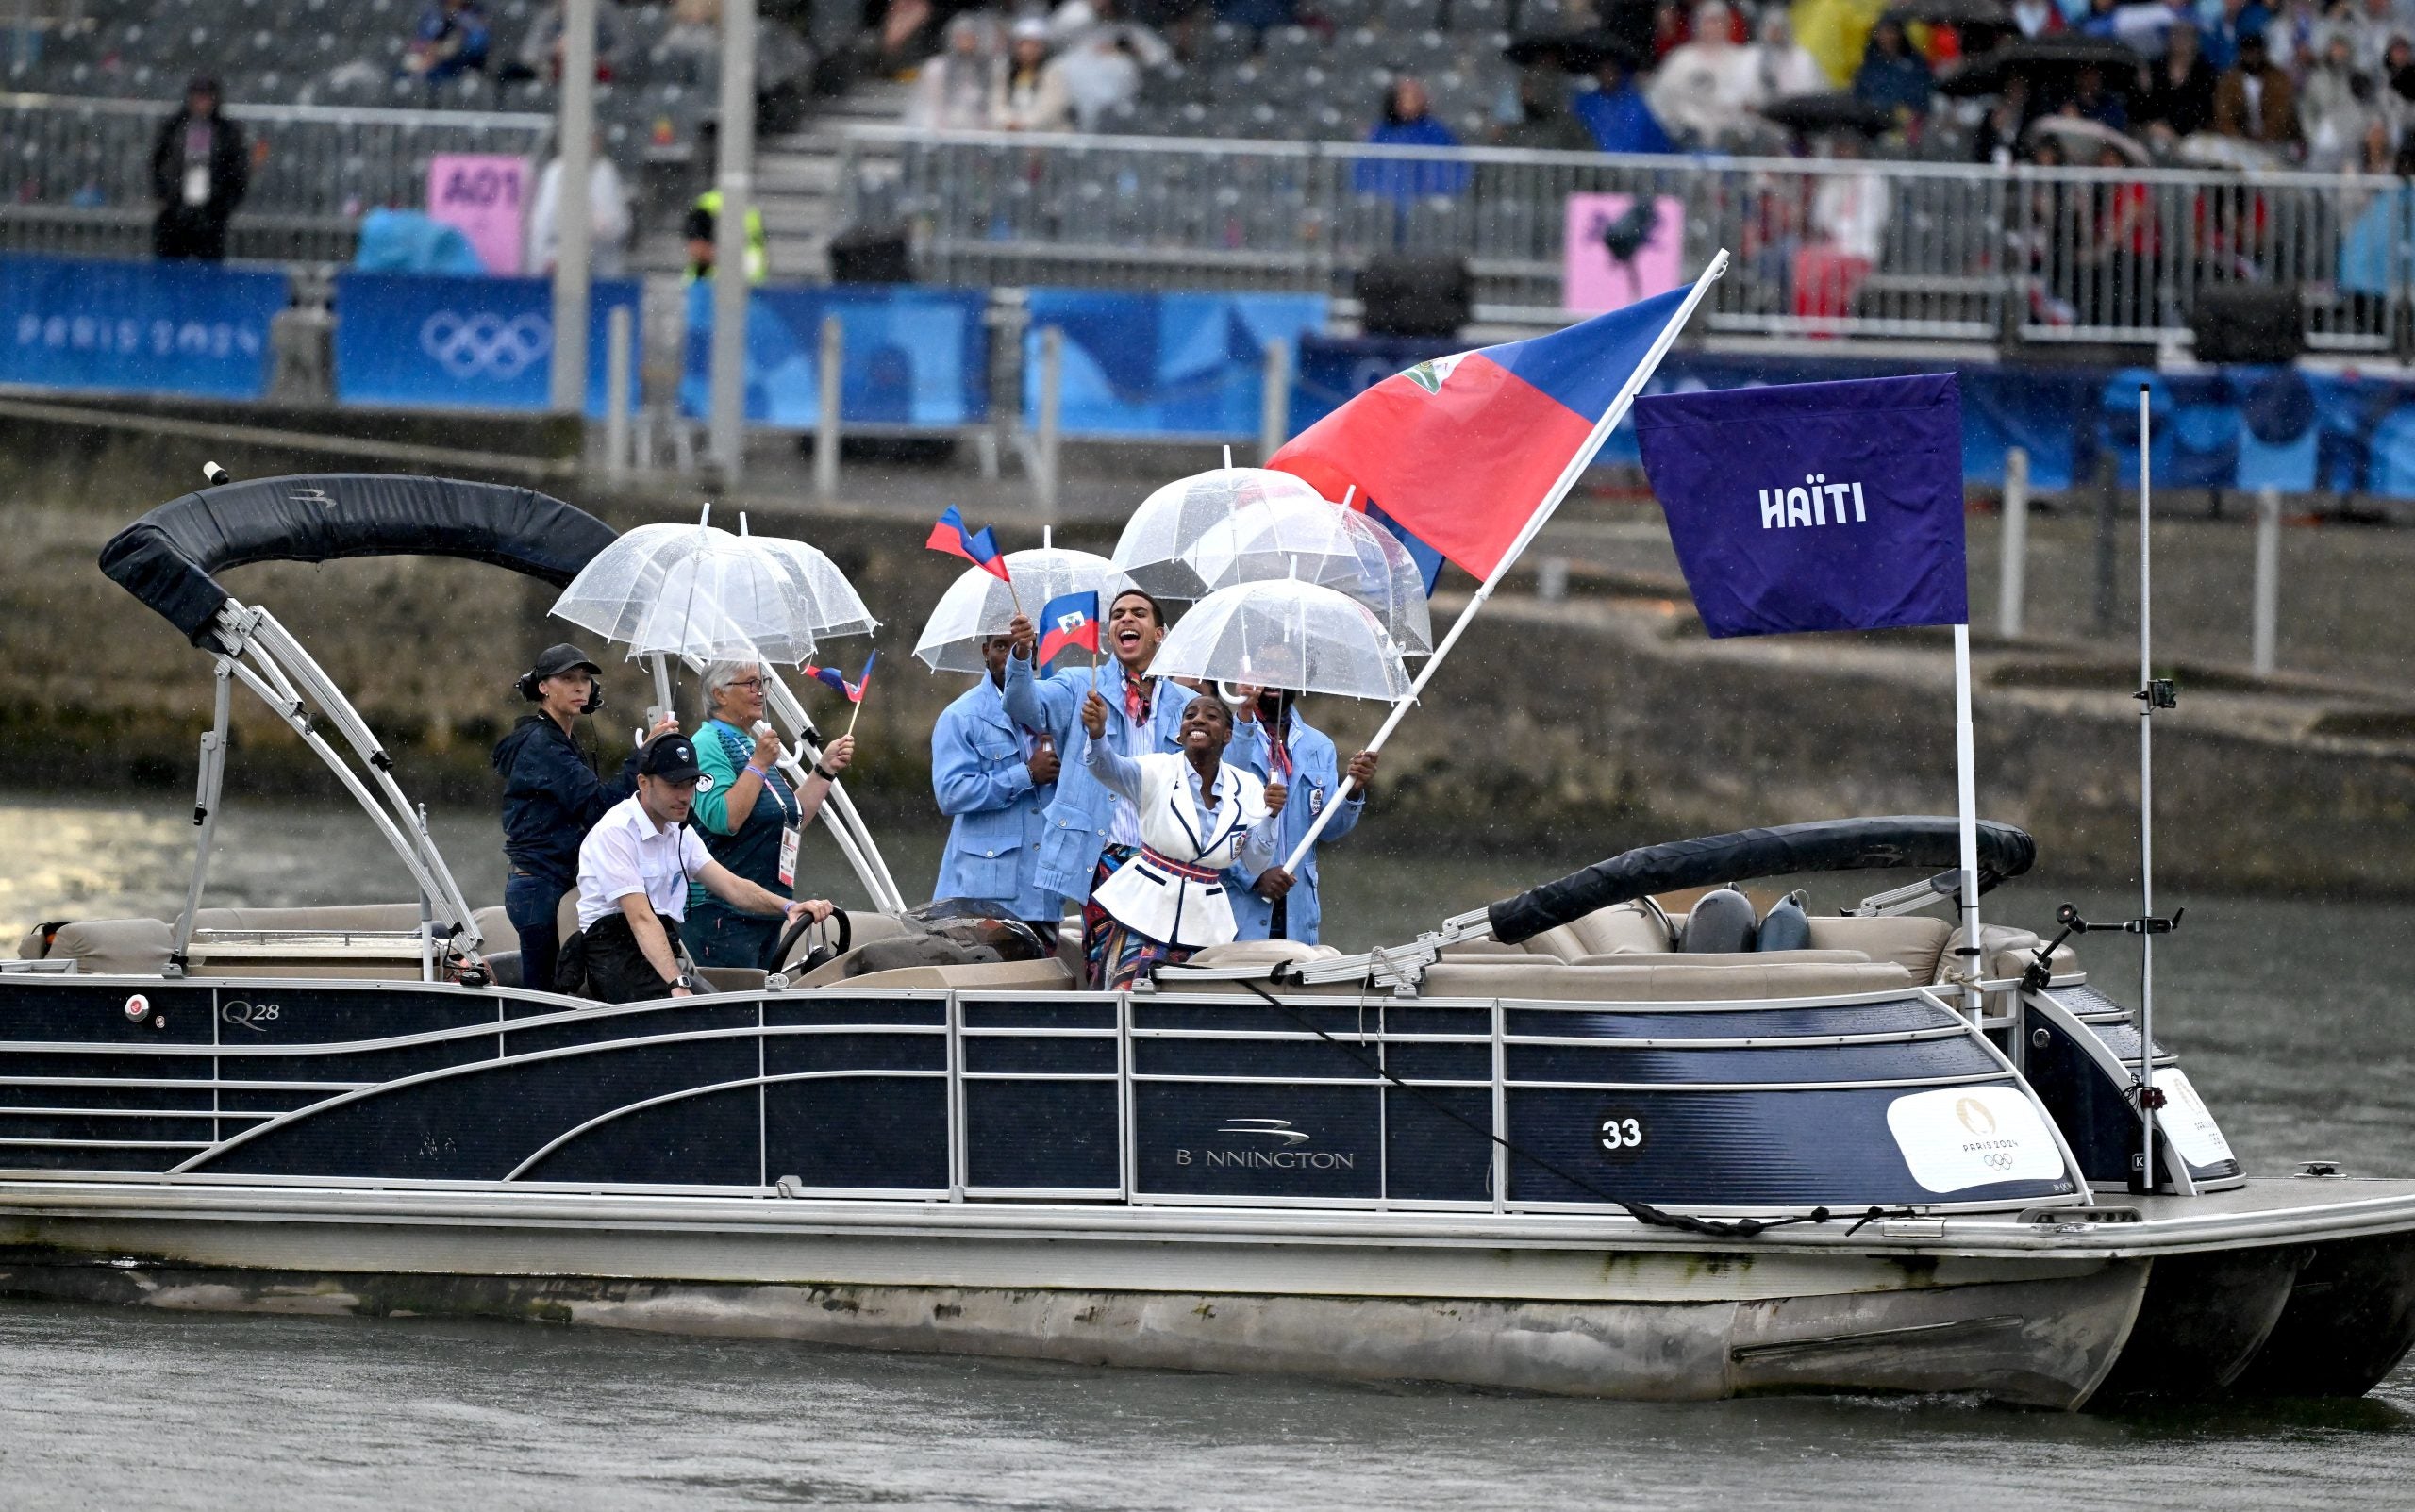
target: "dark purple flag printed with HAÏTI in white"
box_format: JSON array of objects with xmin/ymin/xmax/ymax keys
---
[{"xmin": 1635, "ymin": 372, "xmax": 1971, "ymax": 635}]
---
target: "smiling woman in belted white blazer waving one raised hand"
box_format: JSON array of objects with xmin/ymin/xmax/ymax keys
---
[{"xmin": 1082, "ymin": 693, "xmax": 1285, "ymax": 990}]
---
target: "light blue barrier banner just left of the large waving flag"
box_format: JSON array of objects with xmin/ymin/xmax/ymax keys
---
[{"xmin": 1024, "ymin": 290, "xmax": 1325, "ymax": 440}]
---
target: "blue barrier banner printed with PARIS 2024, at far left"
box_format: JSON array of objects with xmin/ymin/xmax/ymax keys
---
[{"xmin": 0, "ymin": 254, "xmax": 288, "ymax": 399}]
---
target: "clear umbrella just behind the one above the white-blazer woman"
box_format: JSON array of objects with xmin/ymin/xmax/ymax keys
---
[{"xmin": 1189, "ymin": 498, "xmax": 1435, "ymax": 657}]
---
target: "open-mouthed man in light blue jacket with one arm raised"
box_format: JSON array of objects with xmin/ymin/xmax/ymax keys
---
[{"xmin": 1005, "ymin": 590, "xmax": 1193, "ymax": 959}]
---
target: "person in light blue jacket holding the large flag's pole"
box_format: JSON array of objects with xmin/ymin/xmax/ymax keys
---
[{"xmin": 1224, "ymin": 689, "xmax": 1374, "ymax": 944}]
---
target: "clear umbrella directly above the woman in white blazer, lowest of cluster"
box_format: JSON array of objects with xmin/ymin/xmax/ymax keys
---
[{"xmin": 1150, "ymin": 580, "xmax": 1407, "ymax": 701}]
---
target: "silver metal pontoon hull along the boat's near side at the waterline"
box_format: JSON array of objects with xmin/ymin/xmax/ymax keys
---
[{"xmin": 0, "ymin": 1203, "xmax": 2149, "ymax": 1408}]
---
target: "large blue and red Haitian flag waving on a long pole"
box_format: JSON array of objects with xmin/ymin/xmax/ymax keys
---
[{"xmin": 1268, "ymin": 290, "xmax": 1690, "ymax": 577}]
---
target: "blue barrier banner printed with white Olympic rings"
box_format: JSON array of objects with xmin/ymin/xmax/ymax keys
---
[{"xmin": 336, "ymin": 273, "xmax": 640, "ymax": 415}]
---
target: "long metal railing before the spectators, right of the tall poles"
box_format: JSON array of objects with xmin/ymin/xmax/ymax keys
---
[{"xmin": 841, "ymin": 125, "xmax": 2415, "ymax": 350}]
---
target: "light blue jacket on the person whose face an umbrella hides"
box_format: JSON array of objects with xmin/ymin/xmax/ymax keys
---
[{"xmin": 930, "ymin": 676, "xmax": 1058, "ymax": 921}]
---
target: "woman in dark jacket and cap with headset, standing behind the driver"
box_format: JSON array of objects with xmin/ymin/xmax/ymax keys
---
[{"xmin": 492, "ymin": 645, "xmax": 678, "ymax": 992}]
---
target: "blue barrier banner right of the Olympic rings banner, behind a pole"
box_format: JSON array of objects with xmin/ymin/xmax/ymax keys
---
[{"xmin": 678, "ymin": 283, "xmax": 991, "ymax": 430}]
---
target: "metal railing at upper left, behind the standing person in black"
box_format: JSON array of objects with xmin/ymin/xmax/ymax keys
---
[{"xmin": 0, "ymin": 94, "xmax": 553, "ymax": 261}]
